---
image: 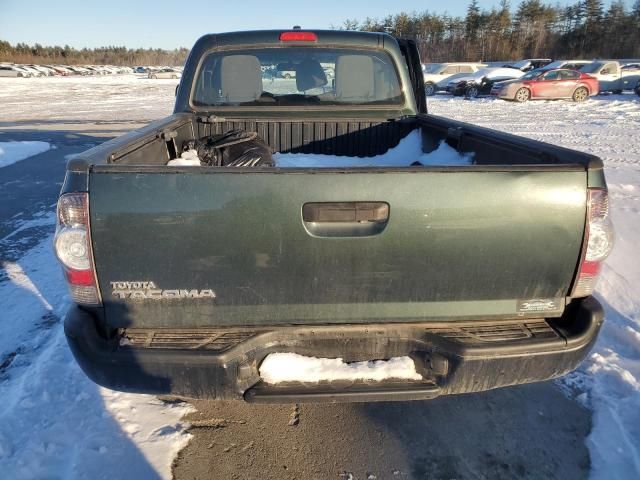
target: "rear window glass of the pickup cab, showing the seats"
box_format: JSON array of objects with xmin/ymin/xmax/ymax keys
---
[{"xmin": 192, "ymin": 47, "xmax": 404, "ymax": 107}]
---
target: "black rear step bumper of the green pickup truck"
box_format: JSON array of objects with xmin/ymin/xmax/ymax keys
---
[{"xmin": 65, "ymin": 297, "xmax": 603, "ymax": 403}]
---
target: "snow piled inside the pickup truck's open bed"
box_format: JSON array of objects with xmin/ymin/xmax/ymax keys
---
[{"xmin": 273, "ymin": 130, "xmax": 473, "ymax": 168}]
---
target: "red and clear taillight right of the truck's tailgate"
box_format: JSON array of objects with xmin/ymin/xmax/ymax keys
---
[{"xmin": 571, "ymin": 188, "xmax": 613, "ymax": 297}]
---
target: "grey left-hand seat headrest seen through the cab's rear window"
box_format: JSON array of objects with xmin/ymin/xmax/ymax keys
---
[{"xmin": 220, "ymin": 55, "xmax": 262, "ymax": 103}]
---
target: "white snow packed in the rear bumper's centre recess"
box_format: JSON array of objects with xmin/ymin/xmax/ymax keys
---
[{"xmin": 260, "ymin": 353, "xmax": 422, "ymax": 384}]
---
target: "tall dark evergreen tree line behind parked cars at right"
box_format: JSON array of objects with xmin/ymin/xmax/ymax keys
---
[{"xmin": 340, "ymin": 0, "xmax": 640, "ymax": 62}]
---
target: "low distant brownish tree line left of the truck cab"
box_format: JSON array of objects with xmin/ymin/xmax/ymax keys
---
[{"xmin": 0, "ymin": 40, "xmax": 189, "ymax": 66}]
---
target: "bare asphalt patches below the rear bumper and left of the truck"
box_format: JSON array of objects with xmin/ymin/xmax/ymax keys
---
[{"xmin": 0, "ymin": 124, "xmax": 591, "ymax": 480}]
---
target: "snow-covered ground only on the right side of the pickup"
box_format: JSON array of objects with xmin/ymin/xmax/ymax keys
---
[{"xmin": 429, "ymin": 94, "xmax": 640, "ymax": 479}]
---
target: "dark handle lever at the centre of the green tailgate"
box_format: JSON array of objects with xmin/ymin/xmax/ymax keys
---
[{"xmin": 302, "ymin": 202, "xmax": 389, "ymax": 223}]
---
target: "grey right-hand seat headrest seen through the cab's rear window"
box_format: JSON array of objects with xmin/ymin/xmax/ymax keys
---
[{"xmin": 336, "ymin": 55, "xmax": 375, "ymax": 102}]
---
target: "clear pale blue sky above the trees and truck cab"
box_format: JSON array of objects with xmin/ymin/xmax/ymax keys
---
[{"xmin": 0, "ymin": 0, "xmax": 631, "ymax": 48}]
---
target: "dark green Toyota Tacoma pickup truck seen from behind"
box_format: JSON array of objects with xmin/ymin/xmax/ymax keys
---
[{"xmin": 55, "ymin": 29, "xmax": 612, "ymax": 402}]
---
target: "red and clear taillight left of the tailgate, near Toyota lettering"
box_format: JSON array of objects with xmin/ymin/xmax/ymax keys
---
[{"xmin": 54, "ymin": 193, "xmax": 101, "ymax": 305}]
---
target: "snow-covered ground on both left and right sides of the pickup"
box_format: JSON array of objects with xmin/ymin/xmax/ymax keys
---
[{"xmin": 0, "ymin": 75, "xmax": 640, "ymax": 478}]
